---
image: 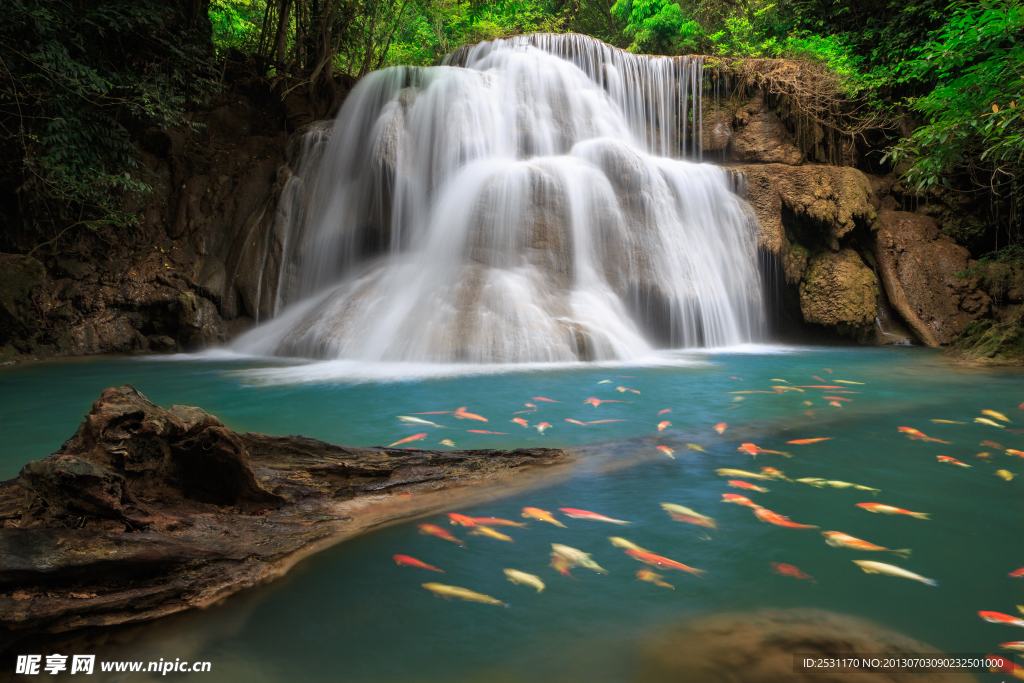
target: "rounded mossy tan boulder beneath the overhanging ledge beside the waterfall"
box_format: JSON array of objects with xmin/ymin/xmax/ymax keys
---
[{"xmin": 800, "ymin": 249, "xmax": 879, "ymax": 341}]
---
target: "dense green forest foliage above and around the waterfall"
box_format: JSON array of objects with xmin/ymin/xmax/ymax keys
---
[{"xmin": 0, "ymin": 0, "xmax": 1024, "ymax": 259}]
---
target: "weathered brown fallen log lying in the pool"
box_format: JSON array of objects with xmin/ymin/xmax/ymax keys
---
[{"xmin": 0, "ymin": 386, "xmax": 569, "ymax": 651}]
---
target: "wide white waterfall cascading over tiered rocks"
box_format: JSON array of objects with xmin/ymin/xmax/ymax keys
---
[{"xmin": 237, "ymin": 35, "xmax": 765, "ymax": 362}]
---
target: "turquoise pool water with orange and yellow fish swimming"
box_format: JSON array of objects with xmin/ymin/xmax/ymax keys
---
[{"xmin": 0, "ymin": 348, "xmax": 1024, "ymax": 682}]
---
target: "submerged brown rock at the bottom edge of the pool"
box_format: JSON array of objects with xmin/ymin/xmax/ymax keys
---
[{"xmin": 633, "ymin": 609, "xmax": 975, "ymax": 683}]
